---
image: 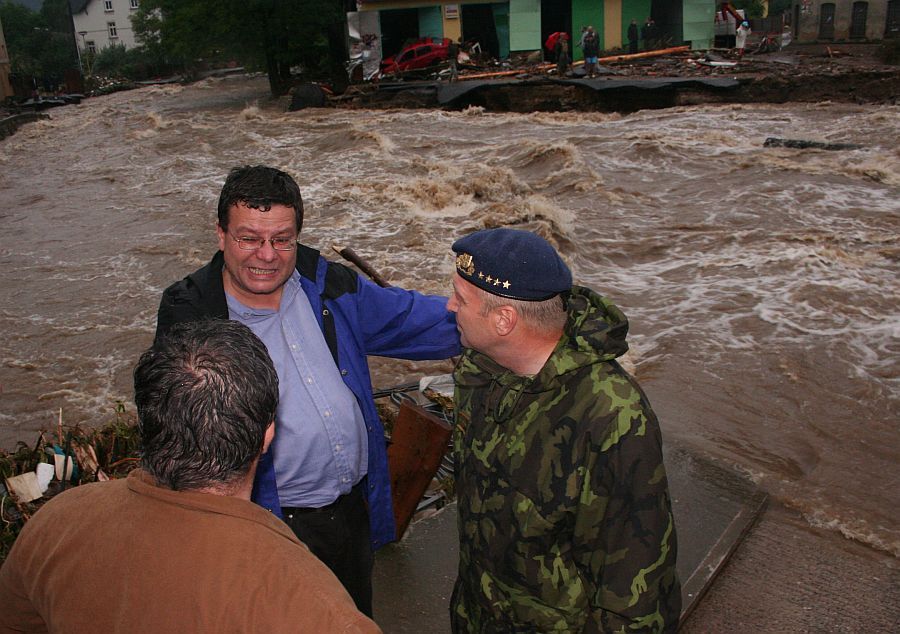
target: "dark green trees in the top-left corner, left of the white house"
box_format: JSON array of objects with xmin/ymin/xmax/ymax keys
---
[{"xmin": 0, "ymin": 0, "xmax": 78, "ymax": 84}]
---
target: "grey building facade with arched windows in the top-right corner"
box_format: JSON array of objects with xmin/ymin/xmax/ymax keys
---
[{"xmin": 792, "ymin": 0, "xmax": 900, "ymax": 42}]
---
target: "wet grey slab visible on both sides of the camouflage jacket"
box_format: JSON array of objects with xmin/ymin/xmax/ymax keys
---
[{"xmin": 374, "ymin": 447, "xmax": 765, "ymax": 634}]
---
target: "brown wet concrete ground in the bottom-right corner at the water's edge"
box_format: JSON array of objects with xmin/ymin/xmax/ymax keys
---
[{"xmin": 684, "ymin": 504, "xmax": 900, "ymax": 634}]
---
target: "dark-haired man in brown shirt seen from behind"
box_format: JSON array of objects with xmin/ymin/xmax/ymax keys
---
[{"xmin": 0, "ymin": 320, "xmax": 380, "ymax": 634}]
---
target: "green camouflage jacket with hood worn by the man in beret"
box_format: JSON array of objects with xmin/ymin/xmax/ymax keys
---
[{"xmin": 451, "ymin": 287, "xmax": 681, "ymax": 633}]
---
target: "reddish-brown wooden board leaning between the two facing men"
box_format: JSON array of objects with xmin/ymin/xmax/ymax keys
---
[{"xmin": 388, "ymin": 401, "xmax": 451, "ymax": 539}]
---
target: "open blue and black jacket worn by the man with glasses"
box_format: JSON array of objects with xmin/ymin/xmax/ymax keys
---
[{"xmin": 156, "ymin": 245, "xmax": 460, "ymax": 549}]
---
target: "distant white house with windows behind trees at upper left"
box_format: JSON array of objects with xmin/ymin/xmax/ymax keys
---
[{"xmin": 69, "ymin": 0, "xmax": 140, "ymax": 53}]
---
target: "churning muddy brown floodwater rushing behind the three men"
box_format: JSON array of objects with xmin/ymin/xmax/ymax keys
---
[{"xmin": 0, "ymin": 77, "xmax": 900, "ymax": 557}]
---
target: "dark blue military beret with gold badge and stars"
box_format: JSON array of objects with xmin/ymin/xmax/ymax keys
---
[{"xmin": 453, "ymin": 228, "xmax": 572, "ymax": 302}]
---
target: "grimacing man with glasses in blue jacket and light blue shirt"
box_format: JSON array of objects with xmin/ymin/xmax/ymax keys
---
[{"xmin": 156, "ymin": 166, "xmax": 459, "ymax": 616}]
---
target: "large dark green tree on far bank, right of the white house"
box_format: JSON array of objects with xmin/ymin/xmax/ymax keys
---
[{"xmin": 132, "ymin": 0, "xmax": 346, "ymax": 95}]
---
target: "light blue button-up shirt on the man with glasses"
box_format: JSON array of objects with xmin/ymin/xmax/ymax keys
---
[{"xmin": 226, "ymin": 271, "xmax": 368, "ymax": 508}]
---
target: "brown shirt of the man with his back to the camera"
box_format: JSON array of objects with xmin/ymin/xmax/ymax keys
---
[{"xmin": 0, "ymin": 471, "xmax": 380, "ymax": 634}]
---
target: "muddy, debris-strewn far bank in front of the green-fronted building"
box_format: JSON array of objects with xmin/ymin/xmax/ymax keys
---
[{"xmin": 344, "ymin": 44, "xmax": 900, "ymax": 112}]
